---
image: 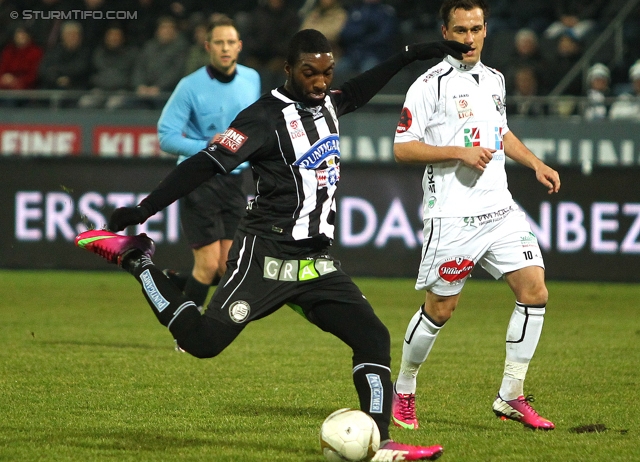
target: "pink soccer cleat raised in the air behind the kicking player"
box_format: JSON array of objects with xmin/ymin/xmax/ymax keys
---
[{"xmin": 75, "ymin": 229, "xmax": 156, "ymax": 266}]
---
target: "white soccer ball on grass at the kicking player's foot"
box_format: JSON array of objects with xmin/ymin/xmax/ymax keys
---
[{"xmin": 320, "ymin": 408, "xmax": 380, "ymax": 462}]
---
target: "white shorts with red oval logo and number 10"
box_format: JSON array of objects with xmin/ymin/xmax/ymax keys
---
[{"xmin": 416, "ymin": 205, "xmax": 544, "ymax": 296}]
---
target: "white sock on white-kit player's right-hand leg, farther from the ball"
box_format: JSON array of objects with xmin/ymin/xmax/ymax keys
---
[{"xmin": 499, "ymin": 302, "xmax": 545, "ymax": 401}]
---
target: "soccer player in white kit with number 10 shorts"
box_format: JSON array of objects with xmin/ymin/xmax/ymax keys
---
[{"xmin": 393, "ymin": 0, "xmax": 560, "ymax": 430}]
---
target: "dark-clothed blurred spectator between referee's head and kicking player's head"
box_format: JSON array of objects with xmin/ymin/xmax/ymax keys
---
[{"xmin": 241, "ymin": 0, "xmax": 300, "ymax": 89}]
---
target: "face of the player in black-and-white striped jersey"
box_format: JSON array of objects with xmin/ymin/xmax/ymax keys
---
[{"xmin": 285, "ymin": 53, "xmax": 335, "ymax": 106}]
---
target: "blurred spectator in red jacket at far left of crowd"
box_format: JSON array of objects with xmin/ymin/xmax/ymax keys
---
[{"xmin": 0, "ymin": 26, "xmax": 43, "ymax": 90}]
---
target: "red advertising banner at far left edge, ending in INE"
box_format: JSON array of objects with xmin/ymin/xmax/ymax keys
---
[{"xmin": 0, "ymin": 124, "xmax": 82, "ymax": 156}]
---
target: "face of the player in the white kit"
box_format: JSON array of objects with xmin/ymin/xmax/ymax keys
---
[{"xmin": 442, "ymin": 8, "xmax": 487, "ymax": 66}]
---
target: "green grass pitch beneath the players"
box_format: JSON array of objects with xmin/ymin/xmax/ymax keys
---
[{"xmin": 0, "ymin": 271, "xmax": 640, "ymax": 462}]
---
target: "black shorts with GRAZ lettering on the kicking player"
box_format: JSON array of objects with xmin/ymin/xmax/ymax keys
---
[{"xmin": 205, "ymin": 231, "xmax": 373, "ymax": 327}]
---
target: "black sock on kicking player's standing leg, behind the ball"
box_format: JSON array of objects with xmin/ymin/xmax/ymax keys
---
[{"xmin": 353, "ymin": 363, "xmax": 393, "ymax": 441}]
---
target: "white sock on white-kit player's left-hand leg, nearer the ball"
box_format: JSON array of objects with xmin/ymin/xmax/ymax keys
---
[{"xmin": 395, "ymin": 307, "xmax": 442, "ymax": 394}]
